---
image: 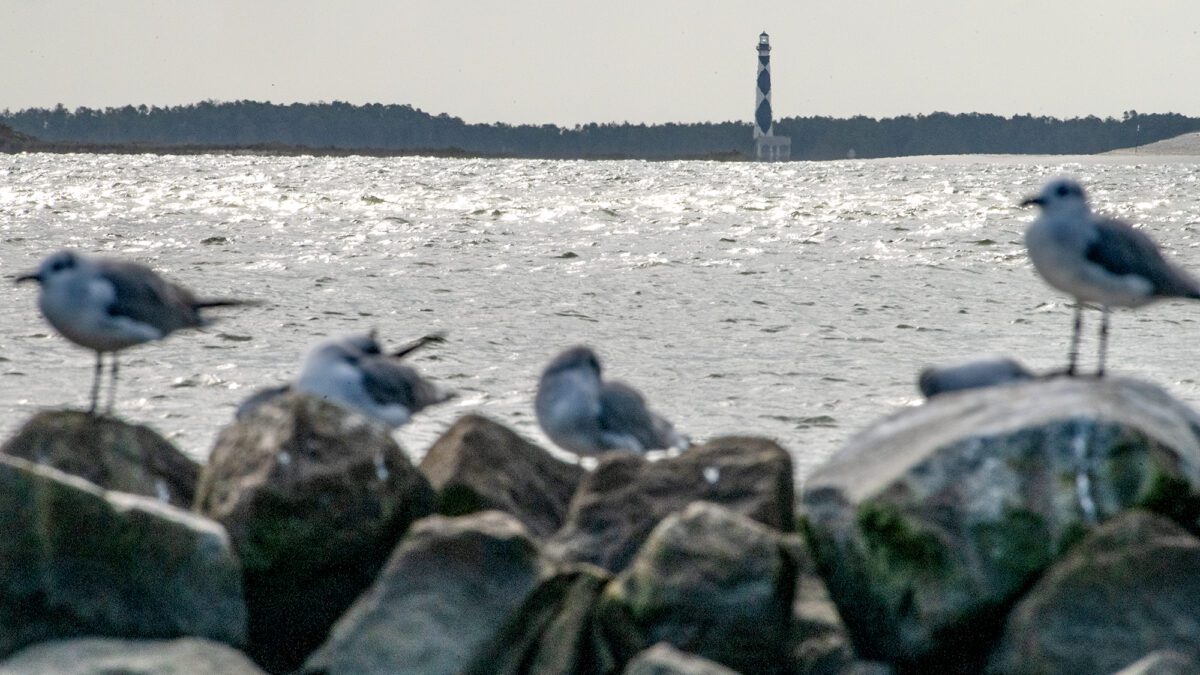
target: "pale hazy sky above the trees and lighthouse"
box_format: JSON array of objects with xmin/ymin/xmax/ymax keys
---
[{"xmin": 0, "ymin": 0, "xmax": 1200, "ymax": 125}]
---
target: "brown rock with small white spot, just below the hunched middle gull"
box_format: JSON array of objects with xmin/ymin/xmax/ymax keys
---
[{"xmin": 547, "ymin": 436, "xmax": 793, "ymax": 572}]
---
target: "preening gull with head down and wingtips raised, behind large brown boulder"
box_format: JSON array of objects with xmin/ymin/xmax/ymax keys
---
[{"xmin": 288, "ymin": 330, "xmax": 454, "ymax": 429}]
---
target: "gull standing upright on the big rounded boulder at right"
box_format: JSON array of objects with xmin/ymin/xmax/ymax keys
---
[{"xmin": 1021, "ymin": 178, "xmax": 1200, "ymax": 377}]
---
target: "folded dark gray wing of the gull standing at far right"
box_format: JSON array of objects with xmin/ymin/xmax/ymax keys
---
[{"xmin": 1085, "ymin": 220, "xmax": 1200, "ymax": 298}]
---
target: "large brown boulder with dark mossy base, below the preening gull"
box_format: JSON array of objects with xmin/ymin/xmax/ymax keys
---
[{"xmin": 197, "ymin": 393, "xmax": 434, "ymax": 671}]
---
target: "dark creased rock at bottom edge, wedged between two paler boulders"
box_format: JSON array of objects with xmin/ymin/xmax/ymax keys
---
[{"xmin": 463, "ymin": 563, "xmax": 642, "ymax": 675}]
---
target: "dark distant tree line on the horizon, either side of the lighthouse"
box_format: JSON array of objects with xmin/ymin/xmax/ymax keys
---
[{"xmin": 0, "ymin": 101, "xmax": 1200, "ymax": 160}]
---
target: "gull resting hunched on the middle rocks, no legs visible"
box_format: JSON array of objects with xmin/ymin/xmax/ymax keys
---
[{"xmin": 534, "ymin": 347, "xmax": 690, "ymax": 455}]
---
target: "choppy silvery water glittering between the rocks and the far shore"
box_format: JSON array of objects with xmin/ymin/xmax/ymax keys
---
[{"xmin": 0, "ymin": 155, "xmax": 1200, "ymax": 476}]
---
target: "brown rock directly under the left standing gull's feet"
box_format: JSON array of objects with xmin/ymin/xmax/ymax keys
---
[{"xmin": 0, "ymin": 411, "xmax": 200, "ymax": 509}]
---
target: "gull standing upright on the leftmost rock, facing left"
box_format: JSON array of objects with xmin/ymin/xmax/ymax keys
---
[{"xmin": 17, "ymin": 250, "xmax": 257, "ymax": 414}]
